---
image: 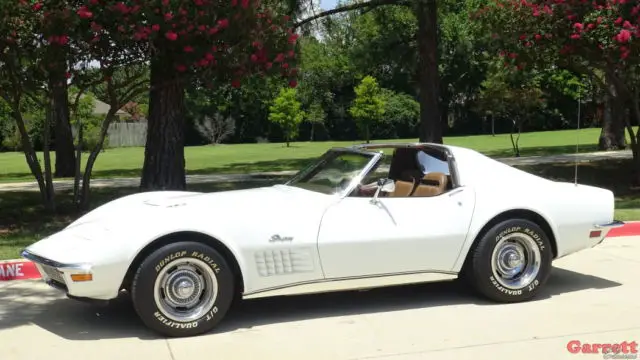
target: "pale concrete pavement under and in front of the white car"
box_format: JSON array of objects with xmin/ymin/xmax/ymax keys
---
[{"xmin": 0, "ymin": 237, "xmax": 640, "ymax": 360}]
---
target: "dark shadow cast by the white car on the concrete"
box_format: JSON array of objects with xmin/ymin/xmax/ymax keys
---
[{"xmin": 0, "ymin": 267, "xmax": 621, "ymax": 341}]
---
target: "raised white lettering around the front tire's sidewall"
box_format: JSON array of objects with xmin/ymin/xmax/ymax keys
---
[{"xmin": 153, "ymin": 249, "xmax": 223, "ymax": 330}]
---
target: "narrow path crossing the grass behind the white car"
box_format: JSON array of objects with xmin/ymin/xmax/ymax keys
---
[{"xmin": 0, "ymin": 150, "xmax": 632, "ymax": 192}]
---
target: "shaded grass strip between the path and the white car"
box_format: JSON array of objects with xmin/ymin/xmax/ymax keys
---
[{"xmin": 0, "ymin": 156, "xmax": 640, "ymax": 260}]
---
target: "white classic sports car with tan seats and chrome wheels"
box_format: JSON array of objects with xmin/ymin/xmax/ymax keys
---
[{"xmin": 22, "ymin": 144, "xmax": 622, "ymax": 336}]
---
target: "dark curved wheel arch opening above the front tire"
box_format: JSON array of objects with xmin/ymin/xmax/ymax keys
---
[{"xmin": 120, "ymin": 231, "xmax": 244, "ymax": 294}]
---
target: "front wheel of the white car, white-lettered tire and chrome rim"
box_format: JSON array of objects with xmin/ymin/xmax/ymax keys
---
[{"xmin": 131, "ymin": 242, "xmax": 235, "ymax": 337}]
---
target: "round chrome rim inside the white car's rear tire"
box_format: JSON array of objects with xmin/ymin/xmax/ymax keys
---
[{"xmin": 491, "ymin": 233, "xmax": 542, "ymax": 289}]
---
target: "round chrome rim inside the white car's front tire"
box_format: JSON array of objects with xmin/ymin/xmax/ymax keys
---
[{"xmin": 153, "ymin": 258, "xmax": 218, "ymax": 322}]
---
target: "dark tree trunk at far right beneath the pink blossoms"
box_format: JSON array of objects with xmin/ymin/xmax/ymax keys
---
[{"xmin": 598, "ymin": 76, "xmax": 627, "ymax": 151}]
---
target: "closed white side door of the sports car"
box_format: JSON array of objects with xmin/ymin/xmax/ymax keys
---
[{"xmin": 318, "ymin": 187, "xmax": 475, "ymax": 279}]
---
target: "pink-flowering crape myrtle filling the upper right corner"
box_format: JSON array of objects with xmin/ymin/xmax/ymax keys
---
[{"xmin": 475, "ymin": 0, "xmax": 640, "ymax": 180}]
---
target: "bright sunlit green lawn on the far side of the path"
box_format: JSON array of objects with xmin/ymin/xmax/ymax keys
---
[{"xmin": 0, "ymin": 129, "xmax": 600, "ymax": 183}]
